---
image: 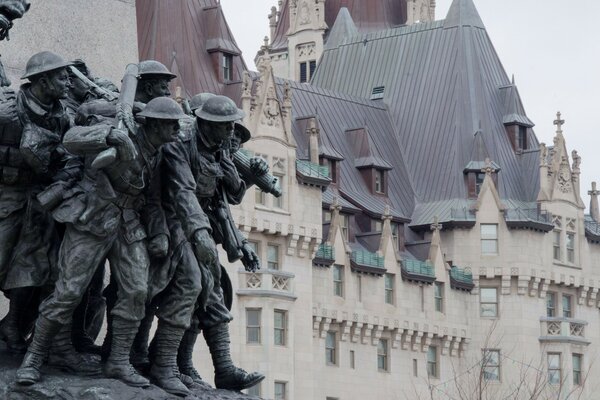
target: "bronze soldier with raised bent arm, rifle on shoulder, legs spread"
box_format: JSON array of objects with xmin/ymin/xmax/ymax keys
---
[{"xmin": 17, "ymin": 97, "xmax": 184, "ymax": 387}]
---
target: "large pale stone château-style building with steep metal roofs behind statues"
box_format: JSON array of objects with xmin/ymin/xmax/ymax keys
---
[{"xmin": 3, "ymin": 0, "xmax": 600, "ymax": 400}]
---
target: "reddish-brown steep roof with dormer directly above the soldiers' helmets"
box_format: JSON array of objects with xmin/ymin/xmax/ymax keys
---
[{"xmin": 136, "ymin": 0, "xmax": 247, "ymax": 98}]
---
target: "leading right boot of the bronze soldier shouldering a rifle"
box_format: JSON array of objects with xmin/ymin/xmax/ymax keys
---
[{"xmin": 104, "ymin": 317, "xmax": 150, "ymax": 387}]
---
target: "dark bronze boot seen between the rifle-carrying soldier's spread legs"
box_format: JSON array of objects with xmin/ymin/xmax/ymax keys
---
[{"xmin": 48, "ymin": 324, "xmax": 101, "ymax": 376}]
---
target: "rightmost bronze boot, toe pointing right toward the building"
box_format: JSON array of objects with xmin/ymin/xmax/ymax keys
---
[{"xmin": 203, "ymin": 323, "xmax": 265, "ymax": 391}]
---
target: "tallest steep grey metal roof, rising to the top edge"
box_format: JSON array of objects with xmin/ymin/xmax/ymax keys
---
[{"xmin": 312, "ymin": 0, "xmax": 539, "ymax": 216}]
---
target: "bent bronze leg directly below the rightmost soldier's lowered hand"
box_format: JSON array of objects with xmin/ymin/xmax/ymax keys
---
[{"xmin": 150, "ymin": 242, "xmax": 202, "ymax": 395}]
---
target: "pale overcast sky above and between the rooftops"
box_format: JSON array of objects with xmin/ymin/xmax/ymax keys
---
[{"xmin": 221, "ymin": 0, "xmax": 600, "ymax": 207}]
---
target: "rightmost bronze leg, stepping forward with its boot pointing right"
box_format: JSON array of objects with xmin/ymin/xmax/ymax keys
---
[{"xmin": 197, "ymin": 266, "xmax": 265, "ymax": 391}]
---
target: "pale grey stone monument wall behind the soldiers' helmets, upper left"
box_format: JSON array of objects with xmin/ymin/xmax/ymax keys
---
[{"xmin": 0, "ymin": 0, "xmax": 138, "ymax": 88}]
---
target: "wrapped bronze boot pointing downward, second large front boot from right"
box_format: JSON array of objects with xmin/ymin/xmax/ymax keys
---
[{"xmin": 150, "ymin": 321, "xmax": 191, "ymax": 396}]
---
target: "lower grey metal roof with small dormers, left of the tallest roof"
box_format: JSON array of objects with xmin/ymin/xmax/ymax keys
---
[{"xmin": 277, "ymin": 79, "xmax": 414, "ymax": 220}]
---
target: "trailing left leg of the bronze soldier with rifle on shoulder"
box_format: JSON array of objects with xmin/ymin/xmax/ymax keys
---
[{"xmin": 17, "ymin": 225, "xmax": 114, "ymax": 385}]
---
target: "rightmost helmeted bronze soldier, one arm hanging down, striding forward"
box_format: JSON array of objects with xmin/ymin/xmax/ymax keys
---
[{"xmin": 156, "ymin": 96, "xmax": 264, "ymax": 390}]
